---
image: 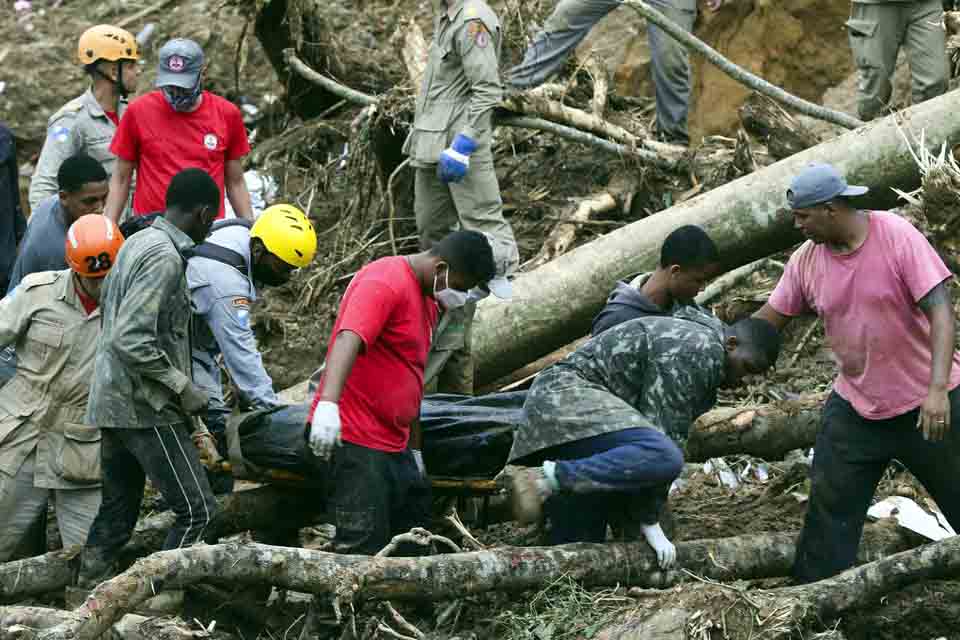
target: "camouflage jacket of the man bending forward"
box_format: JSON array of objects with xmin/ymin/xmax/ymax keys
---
[{"xmin": 510, "ymin": 307, "xmax": 726, "ymax": 460}]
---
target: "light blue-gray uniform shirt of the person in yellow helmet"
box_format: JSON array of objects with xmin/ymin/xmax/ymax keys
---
[{"xmin": 187, "ymin": 224, "xmax": 283, "ymax": 409}]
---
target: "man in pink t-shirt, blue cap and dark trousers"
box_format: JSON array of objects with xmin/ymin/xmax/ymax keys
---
[{"xmin": 755, "ymin": 164, "xmax": 960, "ymax": 582}]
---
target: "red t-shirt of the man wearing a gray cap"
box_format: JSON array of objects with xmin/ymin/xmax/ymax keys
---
[{"xmin": 110, "ymin": 90, "xmax": 250, "ymax": 218}]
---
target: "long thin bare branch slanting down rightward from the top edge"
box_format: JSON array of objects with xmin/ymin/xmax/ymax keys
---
[{"xmin": 623, "ymin": 0, "xmax": 865, "ymax": 129}]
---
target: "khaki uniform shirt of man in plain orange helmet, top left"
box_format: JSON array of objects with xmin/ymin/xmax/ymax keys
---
[{"xmin": 29, "ymin": 89, "xmax": 134, "ymax": 221}]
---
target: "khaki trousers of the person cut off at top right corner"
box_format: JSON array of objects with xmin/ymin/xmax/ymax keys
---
[{"xmin": 847, "ymin": 0, "xmax": 949, "ymax": 120}]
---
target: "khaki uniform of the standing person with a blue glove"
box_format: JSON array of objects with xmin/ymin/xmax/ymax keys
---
[{"xmin": 403, "ymin": 0, "xmax": 520, "ymax": 393}]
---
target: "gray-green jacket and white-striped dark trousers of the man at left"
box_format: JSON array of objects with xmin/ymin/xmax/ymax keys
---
[{"xmin": 80, "ymin": 217, "xmax": 216, "ymax": 585}]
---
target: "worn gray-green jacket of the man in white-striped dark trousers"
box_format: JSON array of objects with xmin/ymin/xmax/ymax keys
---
[{"xmin": 87, "ymin": 217, "xmax": 194, "ymax": 429}]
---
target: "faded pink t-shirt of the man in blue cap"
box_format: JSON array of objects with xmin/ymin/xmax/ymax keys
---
[{"xmin": 770, "ymin": 211, "xmax": 960, "ymax": 420}]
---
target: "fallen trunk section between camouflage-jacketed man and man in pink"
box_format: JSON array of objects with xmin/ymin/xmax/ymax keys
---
[{"xmin": 685, "ymin": 393, "xmax": 828, "ymax": 462}]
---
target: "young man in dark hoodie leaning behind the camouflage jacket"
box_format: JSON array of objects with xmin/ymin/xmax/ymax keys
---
[{"xmin": 590, "ymin": 224, "xmax": 720, "ymax": 336}]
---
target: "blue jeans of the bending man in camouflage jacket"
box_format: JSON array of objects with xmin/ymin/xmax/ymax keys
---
[{"xmin": 537, "ymin": 428, "xmax": 683, "ymax": 544}]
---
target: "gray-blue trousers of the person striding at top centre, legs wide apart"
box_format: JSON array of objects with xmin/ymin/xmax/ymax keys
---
[{"xmin": 507, "ymin": 0, "xmax": 697, "ymax": 144}]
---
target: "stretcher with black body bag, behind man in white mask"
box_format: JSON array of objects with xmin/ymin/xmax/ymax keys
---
[{"xmin": 208, "ymin": 391, "xmax": 526, "ymax": 497}]
